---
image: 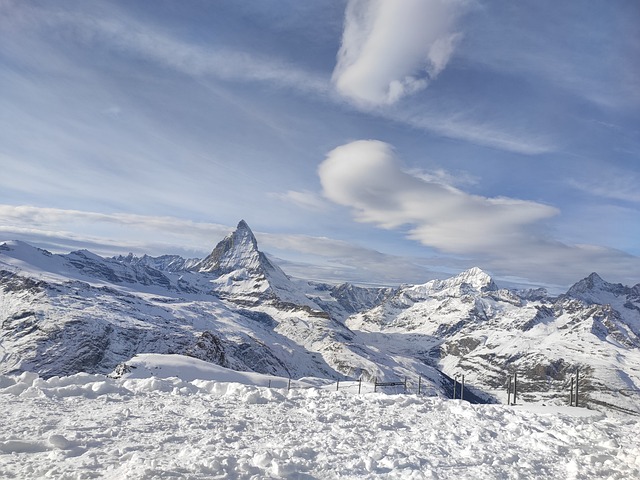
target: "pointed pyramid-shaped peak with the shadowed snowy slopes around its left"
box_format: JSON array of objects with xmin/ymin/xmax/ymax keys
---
[{"xmin": 0, "ymin": 229, "xmax": 451, "ymax": 398}]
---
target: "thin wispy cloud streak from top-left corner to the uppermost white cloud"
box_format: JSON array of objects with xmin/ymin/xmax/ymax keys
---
[{"xmin": 0, "ymin": 1, "xmax": 330, "ymax": 97}]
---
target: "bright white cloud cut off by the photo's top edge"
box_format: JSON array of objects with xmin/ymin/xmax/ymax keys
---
[{"xmin": 333, "ymin": 0, "xmax": 466, "ymax": 107}]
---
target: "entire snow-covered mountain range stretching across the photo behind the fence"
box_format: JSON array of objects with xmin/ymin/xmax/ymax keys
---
[{"xmin": 0, "ymin": 221, "xmax": 640, "ymax": 410}]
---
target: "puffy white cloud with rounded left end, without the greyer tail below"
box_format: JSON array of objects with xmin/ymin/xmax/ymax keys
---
[{"xmin": 319, "ymin": 140, "xmax": 558, "ymax": 254}]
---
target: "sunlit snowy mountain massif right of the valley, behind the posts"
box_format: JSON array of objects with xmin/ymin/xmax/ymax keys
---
[{"xmin": 346, "ymin": 268, "xmax": 640, "ymax": 411}]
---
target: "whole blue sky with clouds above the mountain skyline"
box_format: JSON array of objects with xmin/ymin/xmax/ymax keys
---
[{"xmin": 0, "ymin": 0, "xmax": 640, "ymax": 291}]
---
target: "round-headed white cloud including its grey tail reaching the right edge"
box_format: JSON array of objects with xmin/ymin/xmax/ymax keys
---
[{"xmin": 319, "ymin": 140, "xmax": 640, "ymax": 285}]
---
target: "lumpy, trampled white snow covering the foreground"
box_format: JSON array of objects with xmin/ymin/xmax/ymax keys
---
[{"xmin": 0, "ymin": 356, "xmax": 640, "ymax": 480}]
